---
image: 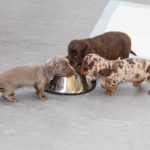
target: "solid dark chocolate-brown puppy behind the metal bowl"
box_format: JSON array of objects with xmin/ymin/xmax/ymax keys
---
[{"xmin": 67, "ymin": 32, "xmax": 136, "ymax": 71}]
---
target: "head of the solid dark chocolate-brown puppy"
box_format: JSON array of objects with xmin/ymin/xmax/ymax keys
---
[{"xmin": 67, "ymin": 40, "xmax": 87, "ymax": 69}]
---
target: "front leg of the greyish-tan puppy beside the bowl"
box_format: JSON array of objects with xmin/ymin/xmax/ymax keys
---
[{"xmin": 37, "ymin": 83, "xmax": 48, "ymax": 100}]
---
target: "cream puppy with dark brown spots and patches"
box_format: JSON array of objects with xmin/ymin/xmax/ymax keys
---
[{"xmin": 80, "ymin": 53, "xmax": 150, "ymax": 95}]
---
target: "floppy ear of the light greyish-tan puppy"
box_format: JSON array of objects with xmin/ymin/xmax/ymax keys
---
[{"xmin": 44, "ymin": 59, "xmax": 57, "ymax": 81}]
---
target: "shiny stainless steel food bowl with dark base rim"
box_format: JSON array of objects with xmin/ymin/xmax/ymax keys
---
[{"xmin": 45, "ymin": 75, "xmax": 96, "ymax": 95}]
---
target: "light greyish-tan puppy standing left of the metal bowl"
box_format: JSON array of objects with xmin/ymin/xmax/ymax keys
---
[{"xmin": 0, "ymin": 56, "xmax": 75, "ymax": 102}]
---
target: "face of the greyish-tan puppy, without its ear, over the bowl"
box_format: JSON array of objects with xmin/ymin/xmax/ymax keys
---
[{"xmin": 54, "ymin": 56, "xmax": 76, "ymax": 76}]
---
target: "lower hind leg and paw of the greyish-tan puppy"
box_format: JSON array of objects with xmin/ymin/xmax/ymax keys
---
[{"xmin": 2, "ymin": 89, "xmax": 17, "ymax": 102}]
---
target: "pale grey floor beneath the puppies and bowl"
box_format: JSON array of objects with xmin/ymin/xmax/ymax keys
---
[{"xmin": 0, "ymin": 0, "xmax": 150, "ymax": 150}]
